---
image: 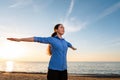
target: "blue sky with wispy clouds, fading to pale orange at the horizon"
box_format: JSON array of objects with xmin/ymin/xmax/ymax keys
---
[{"xmin": 0, "ymin": 0, "xmax": 120, "ymax": 61}]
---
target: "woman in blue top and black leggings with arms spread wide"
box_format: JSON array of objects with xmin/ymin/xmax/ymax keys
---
[{"xmin": 7, "ymin": 24, "xmax": 76, "ymax": 80}]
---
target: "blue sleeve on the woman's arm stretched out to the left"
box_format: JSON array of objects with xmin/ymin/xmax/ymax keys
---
[{"xmin": 34, "ymin": 37, "xmax": 52, "ymax": 44}]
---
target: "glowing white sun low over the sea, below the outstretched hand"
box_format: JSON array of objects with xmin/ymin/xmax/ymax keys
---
[{"xmin": 0, "ymin": 41, "xmax": 26, "ymax": 60}]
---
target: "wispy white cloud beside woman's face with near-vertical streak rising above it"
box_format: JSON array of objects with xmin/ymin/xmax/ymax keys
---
[{"xmin": 61, "ymin": 0, "xmax": 87, "ymax": 33}]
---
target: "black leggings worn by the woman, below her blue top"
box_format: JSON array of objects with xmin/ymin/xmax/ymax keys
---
[{"xmin": 47, "ymin": 69, "xmax": 68, "ymax": 80}]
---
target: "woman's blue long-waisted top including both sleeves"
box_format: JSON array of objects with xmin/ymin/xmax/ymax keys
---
[{"xmin": 34, "ymin": 36, "xmax": 72, "ymax": 71}]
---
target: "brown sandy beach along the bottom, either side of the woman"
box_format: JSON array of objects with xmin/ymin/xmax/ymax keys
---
[{"xmin": 0, "ymin": 72, "xmax": 120, "ymax": 80}]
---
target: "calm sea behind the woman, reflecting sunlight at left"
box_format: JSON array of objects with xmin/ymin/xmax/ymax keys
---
[{"xmin": 0, "ymin": 61, "xmax": 120, "ymax": 75}]
